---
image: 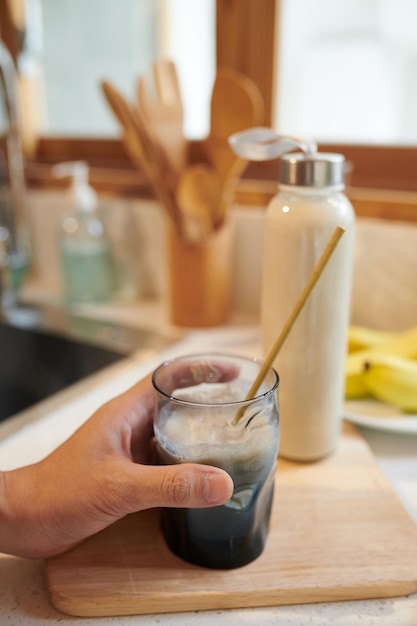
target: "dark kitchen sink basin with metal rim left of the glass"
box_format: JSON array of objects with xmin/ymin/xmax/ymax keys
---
[{"xmin": 0, "ymin": 308, "xmax": 174, "ymax": 422}]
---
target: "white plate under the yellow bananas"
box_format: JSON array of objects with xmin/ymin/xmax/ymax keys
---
[{"xmin": 344, "ymin": 400, "xmax": 417, "ymax": 435}]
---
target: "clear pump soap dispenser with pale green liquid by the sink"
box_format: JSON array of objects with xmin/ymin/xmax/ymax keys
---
[{"xmin": 53, "ymin": 161, "xmax": 114, "ymax": 304}]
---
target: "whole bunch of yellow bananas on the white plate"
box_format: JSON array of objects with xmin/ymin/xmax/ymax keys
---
[{"xmin": 345, "ymin": 326, "xmax": 417, "ymax": 411}]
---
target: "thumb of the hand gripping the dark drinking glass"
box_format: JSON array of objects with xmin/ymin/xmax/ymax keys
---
[{"xmin": 120, "ymin": 463, "xmax": 233, "ymax": 512}]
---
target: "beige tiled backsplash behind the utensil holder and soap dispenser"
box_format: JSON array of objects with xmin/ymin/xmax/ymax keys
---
[{"xmin": 25, "ymin": 191, "xmax": 417, "ymax": 329}]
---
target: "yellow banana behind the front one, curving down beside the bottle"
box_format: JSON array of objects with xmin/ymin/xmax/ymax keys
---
[{"xmin": 345, "ymin": 326, "xmax": 417, "ymax": 400}]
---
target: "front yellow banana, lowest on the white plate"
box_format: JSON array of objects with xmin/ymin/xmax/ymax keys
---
[{"xmin": 363, "ymin": 354, "xmax": 417, "ymax": 413}]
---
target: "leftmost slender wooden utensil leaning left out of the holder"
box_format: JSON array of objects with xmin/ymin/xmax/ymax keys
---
[{"xmin": 101, "ymin": 81, "xmax": 183, "ymax": 234}]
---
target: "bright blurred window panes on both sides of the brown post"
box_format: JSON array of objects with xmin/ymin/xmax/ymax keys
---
[{"xmin": 9, "ymin": 0, "xmax": 417, "ymax": 145}]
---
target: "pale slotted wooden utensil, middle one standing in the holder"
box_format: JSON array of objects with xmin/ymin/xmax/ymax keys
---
[{"xmin": 137, "ymin": 60, "xmax": 187, "ymax": 174}]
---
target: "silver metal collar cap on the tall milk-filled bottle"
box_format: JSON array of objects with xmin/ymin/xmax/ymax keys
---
[{"xmin": 279, "ymin": 152, "xmax": 345, "ymax": 188}]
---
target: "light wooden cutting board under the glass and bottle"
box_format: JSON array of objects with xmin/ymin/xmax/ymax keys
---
[{"xmin": 45, "ymin": 425, "xmax": 417, "ymax": 616}]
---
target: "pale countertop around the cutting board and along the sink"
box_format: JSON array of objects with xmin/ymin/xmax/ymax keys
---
[{"xmin": 0, "ymin": 304, "xmax": 417, "ymax": 626}]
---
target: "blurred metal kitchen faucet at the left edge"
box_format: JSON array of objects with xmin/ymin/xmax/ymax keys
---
[{"xmin": 0, "ymin": 40, "xmax": 30, "ymax": 307}]
